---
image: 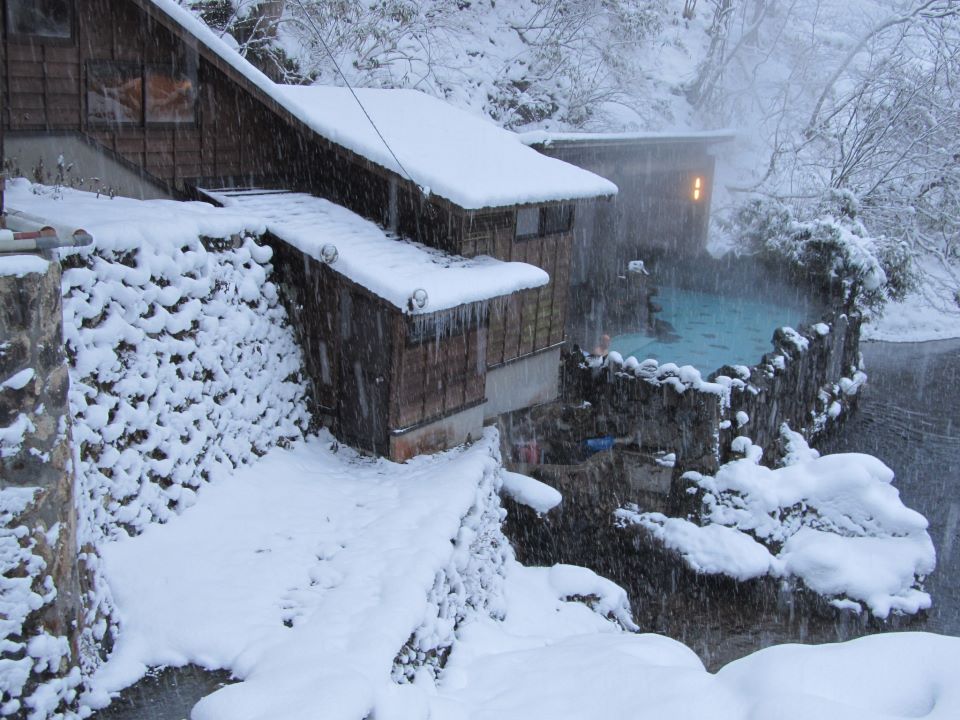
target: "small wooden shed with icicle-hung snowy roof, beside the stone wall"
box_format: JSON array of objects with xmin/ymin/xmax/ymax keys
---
[{"xmin": 209, "ymin": 190, "xmax": 558, "ymax": 459}]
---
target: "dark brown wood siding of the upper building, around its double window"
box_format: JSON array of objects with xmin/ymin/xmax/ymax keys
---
[{"xmin": 0, "ymin": 0, "xmax": 390, "ymax": 211}]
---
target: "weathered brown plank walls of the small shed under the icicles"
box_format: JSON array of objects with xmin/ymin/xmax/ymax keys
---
[{"xmin": 270, "ymin": 238, "xmax": 487, "ymax": 454}]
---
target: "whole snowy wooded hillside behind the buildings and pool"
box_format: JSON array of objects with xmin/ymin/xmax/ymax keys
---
[{"xmin": 189, "ymin": 0, "xmax": 960, "ymax": 339}]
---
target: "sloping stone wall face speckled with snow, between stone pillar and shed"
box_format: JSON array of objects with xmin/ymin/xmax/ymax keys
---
[{"xmin": 63, "ymin": 234, "xmax": 307, "ymax": 536}]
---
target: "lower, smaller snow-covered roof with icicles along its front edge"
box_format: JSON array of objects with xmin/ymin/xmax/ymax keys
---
[{"xmin": 207, "ymin": 191, "xmax": 550, "ymax": 314}]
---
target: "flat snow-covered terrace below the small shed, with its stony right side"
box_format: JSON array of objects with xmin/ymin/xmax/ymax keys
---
[{"xmin": 87, "ymin": 434, "xmax": 508, "ymax": 720}]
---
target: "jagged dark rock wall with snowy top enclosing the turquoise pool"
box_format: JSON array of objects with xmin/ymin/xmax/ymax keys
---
[{"xmin": 563, "ymin": 312, "xmax": 866, "ymax": 476}]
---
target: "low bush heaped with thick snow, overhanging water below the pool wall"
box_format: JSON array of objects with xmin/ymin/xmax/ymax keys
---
[{"xmin": 617, "ymin": 427, "xmax": 936, "ymax": 618}]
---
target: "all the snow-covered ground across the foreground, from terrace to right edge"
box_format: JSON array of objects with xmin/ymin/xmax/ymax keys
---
[{"xmin": 86, "ymin": 431, "xmax": 960, "ymax": 720}]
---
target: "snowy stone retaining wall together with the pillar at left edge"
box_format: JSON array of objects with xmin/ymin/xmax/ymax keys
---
[{"xmin": 0, "ymin": 218, "xmax": 308, "ymax": 718}]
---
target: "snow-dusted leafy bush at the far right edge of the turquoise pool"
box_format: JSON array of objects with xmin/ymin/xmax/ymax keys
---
[{"xmin": 732, "ymin": 192, "xmax": 914, "ymax": 311}]
